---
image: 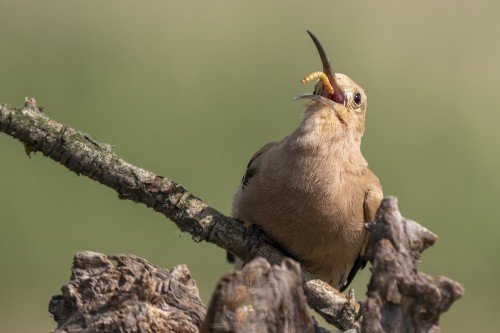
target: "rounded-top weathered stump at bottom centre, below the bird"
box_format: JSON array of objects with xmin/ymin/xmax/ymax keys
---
[{"xmin": 201, "ymin": 258, "xmax": 314, "ymax": 333}]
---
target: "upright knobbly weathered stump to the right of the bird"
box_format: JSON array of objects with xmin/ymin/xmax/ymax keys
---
[{"xmin": 362, "ymin": 197, "xmax": 464, "ymax": 333}]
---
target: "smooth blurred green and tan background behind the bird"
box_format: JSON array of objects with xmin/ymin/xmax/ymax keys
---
[{"xmin": 0, "ymin": 0, "xmax": 500, "ymax": 332}]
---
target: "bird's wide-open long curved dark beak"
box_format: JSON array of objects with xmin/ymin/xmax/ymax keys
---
[{"xmin": 296, "ymin": 30, "xmax": 345, "ymax": 106}]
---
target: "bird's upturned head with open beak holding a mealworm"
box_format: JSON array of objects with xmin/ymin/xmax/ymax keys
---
[{"xmin": 296, "ymin": 31, "xmax": 366, "ymax": 139}]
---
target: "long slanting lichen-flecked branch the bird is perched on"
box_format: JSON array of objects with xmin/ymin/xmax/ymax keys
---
[{"xmin": 0, "ymin": 99, "xmax": 360, "ymax": 330}]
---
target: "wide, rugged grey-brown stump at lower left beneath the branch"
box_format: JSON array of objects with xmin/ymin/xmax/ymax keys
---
[{"xmin": 49, "ymin": 252, "xmax": 206, "ymax": 333}]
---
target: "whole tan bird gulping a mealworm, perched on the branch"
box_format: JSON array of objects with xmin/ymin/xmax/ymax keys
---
[{"xmin": 232, "ymin": 31, "xmax": 382, "ymax": 290}]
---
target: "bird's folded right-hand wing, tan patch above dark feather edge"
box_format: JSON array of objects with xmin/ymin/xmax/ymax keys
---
[{"xmin": 340, "ymin": 182, "xmax": 383, "ymax": 291}]
